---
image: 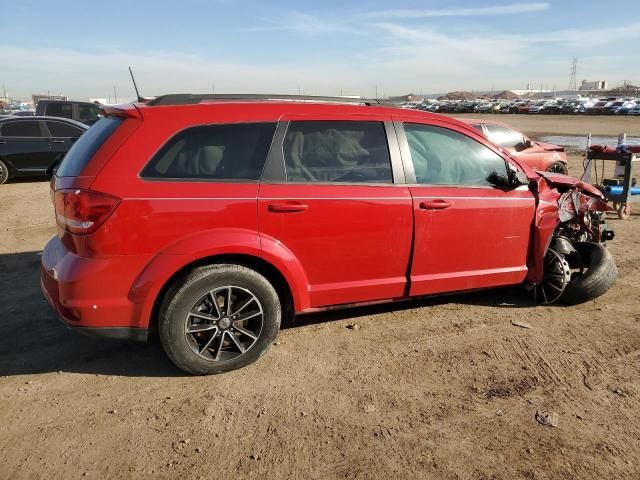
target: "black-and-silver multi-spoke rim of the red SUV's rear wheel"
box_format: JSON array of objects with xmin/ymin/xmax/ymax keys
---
[{"xmin": 184, "ymin": 285, "xmax": 264, "ymax": 362}]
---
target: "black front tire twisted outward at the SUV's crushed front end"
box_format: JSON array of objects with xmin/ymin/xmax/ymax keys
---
[{"xmin": 560, "ymin": 242, "xmax": 618, "ymax": 305}]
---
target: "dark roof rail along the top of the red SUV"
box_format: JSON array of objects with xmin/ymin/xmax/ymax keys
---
[{"xmin": 146, "ymin": 93, "xmax": 393, "ymax": 106}]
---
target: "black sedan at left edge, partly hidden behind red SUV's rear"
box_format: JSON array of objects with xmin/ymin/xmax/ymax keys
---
[{"xmin": 0, "ymin": 117, "xmax": 89, "ymax": 184}]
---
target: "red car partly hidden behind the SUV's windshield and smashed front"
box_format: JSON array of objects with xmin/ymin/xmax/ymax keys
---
[{"xmin": 458, "ymin": 118, "xmax": 569, "ymax": 175}]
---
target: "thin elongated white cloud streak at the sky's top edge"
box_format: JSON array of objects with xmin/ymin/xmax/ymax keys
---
[{"xmin": 367, "ymin": 2, "xmax": 551, "ymax": 19}]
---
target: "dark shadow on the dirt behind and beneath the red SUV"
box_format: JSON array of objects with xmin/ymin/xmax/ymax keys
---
[{"xmin": 0, "ymin": 252, "xmax": 531, "ymax": 377}]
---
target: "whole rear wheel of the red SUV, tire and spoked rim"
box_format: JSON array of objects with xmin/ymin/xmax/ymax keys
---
[{"xmin": 158, "ymin": 264, "xmax": 282, "ymax": 375}]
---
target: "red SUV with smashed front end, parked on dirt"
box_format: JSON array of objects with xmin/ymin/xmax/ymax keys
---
[{"xmin": 41, "ymin": 95, "xmax": 617, "ymax": 374}]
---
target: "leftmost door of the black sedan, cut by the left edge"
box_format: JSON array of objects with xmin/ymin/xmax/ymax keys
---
[{"xmin": 0, "ymin": 119, "xmax": 51, "ymax": 175}]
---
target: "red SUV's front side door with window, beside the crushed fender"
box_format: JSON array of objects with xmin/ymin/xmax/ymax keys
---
[{"xmin": 396, "ymin": 120, "xmax": 535, "ymax": 295}]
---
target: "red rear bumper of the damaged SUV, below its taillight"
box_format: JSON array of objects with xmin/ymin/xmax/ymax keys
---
[{"xmin": 40, "ymin": 233, "xmax": 148, "ymax": 340}]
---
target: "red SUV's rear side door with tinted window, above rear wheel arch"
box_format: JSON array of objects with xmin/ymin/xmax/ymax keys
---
[{"xmin": 258, "ymin": 115, "xmax": 413, "ymax": 307}]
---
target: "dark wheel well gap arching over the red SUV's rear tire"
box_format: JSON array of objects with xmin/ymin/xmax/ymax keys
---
[{"xmin": 149, "ymin": 254, "xmax": 295, "ymax": 329}]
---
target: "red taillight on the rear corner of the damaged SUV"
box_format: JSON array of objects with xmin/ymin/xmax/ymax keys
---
[{"xmin": 53, "ymin": 189, "xmax": 120, "ymax": 234}]
